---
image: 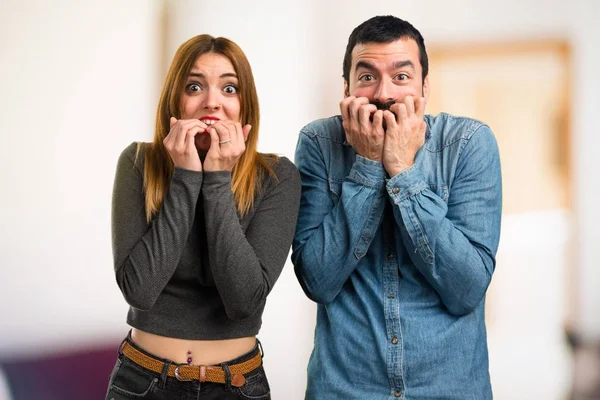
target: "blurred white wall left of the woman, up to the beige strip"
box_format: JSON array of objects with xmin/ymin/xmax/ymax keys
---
[{"xmin": 0, "ymin": 0, "xmax": 160, "ymax": 355}]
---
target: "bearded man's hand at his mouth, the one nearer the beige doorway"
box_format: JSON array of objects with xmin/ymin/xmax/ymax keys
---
[{"xmin": 382, "ymin": 96, "xmax": 427, "ymax": 177}]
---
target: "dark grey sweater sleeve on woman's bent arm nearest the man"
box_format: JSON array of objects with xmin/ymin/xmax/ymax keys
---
[{"xmin": 202, "ymin": 158, "xmax": 300, "ymax": 320}]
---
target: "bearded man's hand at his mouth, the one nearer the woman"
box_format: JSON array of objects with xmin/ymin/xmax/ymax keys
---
[{"xmin": 340, "ymin": 96, "xmax": 384, "ymax": 161}]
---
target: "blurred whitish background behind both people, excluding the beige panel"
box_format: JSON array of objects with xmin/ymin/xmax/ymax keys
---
[{"xmin": 0, "ymin": 0, "xmax": 600, "ymax": 400}]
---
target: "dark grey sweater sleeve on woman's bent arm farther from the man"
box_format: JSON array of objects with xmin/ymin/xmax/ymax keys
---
[{"xmin": 112, "ymin": 143, "xmax": 202, "ymax": 310}]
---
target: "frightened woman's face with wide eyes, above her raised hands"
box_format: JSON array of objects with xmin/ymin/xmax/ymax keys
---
[{"xmin": 181, "ymin": 53, "xmax": 241, "ymax": 151}]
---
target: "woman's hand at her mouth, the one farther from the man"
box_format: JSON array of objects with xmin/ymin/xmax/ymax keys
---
[{"xmin": 163, "ymin": 117, "xmax": 207, "ymax": 171}]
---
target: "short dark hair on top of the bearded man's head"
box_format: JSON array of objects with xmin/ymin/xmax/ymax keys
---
[{"xmin": 343, "ymin": 15, "xmax": 429, "ymax": 82}]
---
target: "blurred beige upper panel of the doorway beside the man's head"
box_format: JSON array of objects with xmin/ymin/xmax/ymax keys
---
[{"xmin": 428, "ymin": 42, "xmax": 570, "ymax": 213}]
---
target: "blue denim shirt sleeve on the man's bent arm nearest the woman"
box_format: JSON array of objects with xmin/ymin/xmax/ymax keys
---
[{"xmin": 292, "ymin": 132, "xmax": 386, "ymax": 304}]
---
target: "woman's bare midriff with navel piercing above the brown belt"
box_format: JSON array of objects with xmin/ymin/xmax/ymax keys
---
[{"xmin": 131, "ymin": 328, "xmax": 256, "ymax": 365}]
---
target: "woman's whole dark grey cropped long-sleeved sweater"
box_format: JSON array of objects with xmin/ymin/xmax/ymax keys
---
[{"xmin": 112, "ymin": 143, "xmax": 300, "ymax": 340}]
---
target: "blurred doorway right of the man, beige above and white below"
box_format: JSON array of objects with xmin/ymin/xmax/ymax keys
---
[{"xmin": 428, "ymin": 41, "xmax": 574, "ymax": 400}]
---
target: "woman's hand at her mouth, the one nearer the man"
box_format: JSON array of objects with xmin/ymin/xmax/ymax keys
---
[{"xmin": 204, "ymin": 120, "xmax": 252, "ymax": 171}]
